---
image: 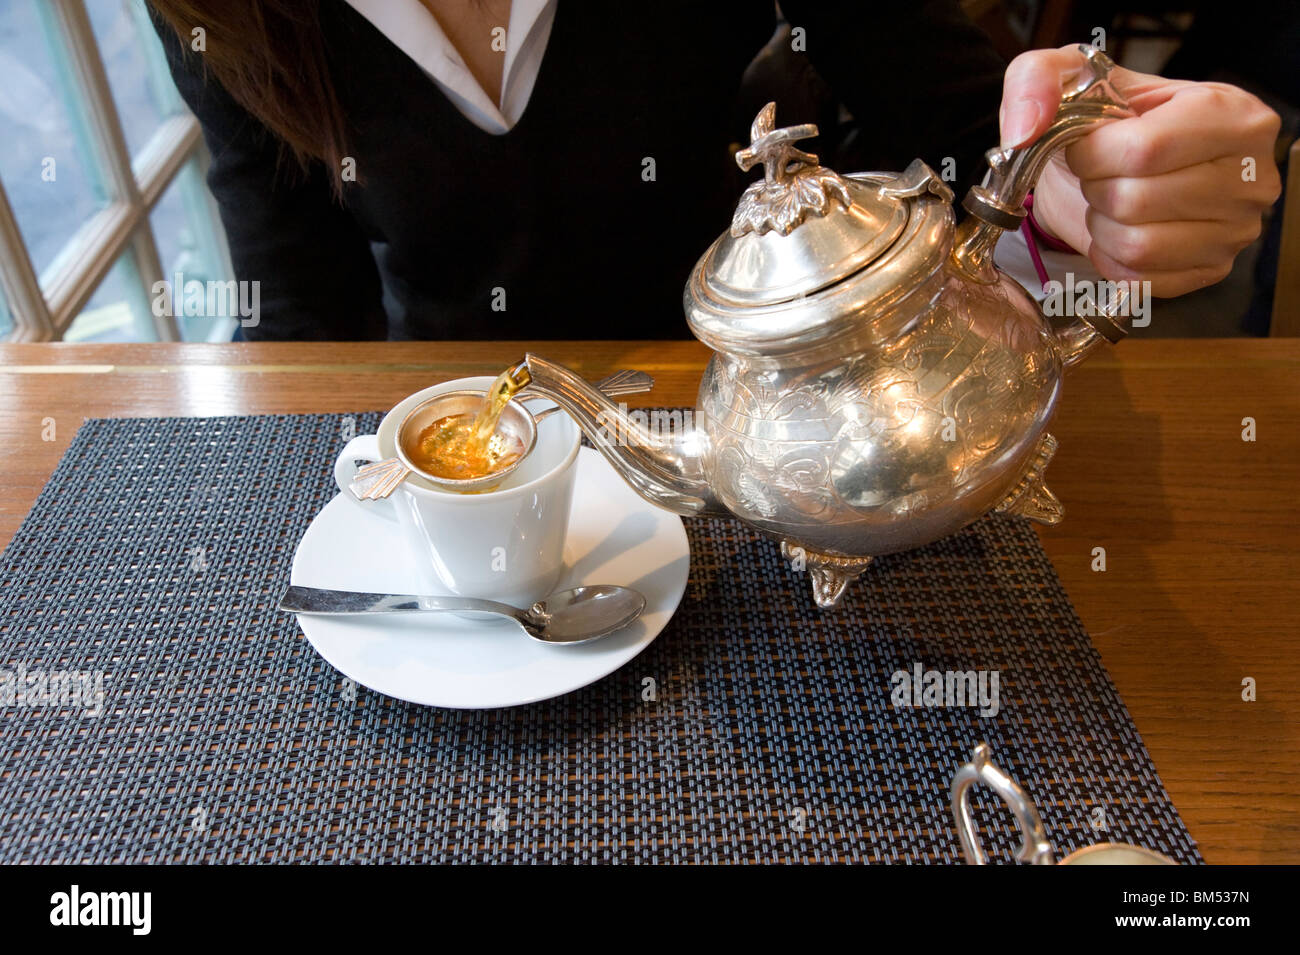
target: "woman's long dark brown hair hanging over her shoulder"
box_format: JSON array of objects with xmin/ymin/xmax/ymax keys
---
[{"xmin": 150, "ymin": 0, "xmax": 347, "ymax": 191}]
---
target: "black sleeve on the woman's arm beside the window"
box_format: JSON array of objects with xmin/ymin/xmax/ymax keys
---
[{"xmin": 151, "ymin": 4, "xmax": 387, "ymax": 340}]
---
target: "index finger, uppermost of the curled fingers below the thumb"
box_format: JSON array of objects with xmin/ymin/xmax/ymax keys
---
[{"xmin": 1066, "ymin": 83, "xmax": 1277, "ymax": 179}]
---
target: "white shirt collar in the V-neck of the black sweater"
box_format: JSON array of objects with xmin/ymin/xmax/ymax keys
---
[{"xmin": 347, "ymin": 0, "xmax": 558, "ymax": 135}]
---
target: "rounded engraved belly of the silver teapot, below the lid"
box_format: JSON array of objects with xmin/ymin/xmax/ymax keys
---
[{"xmin": 701, "ymin": 268, "xmax": 1061, "ymax": 556}]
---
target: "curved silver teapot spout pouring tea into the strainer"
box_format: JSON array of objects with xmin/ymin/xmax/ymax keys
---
[{"xmin": 523, "ymin": 353, "xmax": 727, "ymax": 516}]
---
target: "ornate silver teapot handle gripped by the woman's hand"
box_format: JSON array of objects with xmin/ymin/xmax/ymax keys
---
[{"xmin": 953, "ymin": 44, "xmax": 1134, "ymax": 368}]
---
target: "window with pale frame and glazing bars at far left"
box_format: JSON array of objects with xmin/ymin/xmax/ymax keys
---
[{"xmin": 0, "ymin": 0, "xmax": 238, "ymax": 342}]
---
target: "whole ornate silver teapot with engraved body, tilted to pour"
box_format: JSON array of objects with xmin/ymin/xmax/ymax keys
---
[{"xmin": 517, "ymin": 47, "xmax": 1132, "ymax": 608}]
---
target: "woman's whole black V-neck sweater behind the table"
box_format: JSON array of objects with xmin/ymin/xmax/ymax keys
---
[{"xmin": 152, "ymin": 0, "xmax": 1004, "ymax": 339}]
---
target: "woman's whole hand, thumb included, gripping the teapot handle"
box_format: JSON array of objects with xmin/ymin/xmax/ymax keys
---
[{"xmin": 1000, "ymin": 47, "xmax": 1282, "ymax": 296}]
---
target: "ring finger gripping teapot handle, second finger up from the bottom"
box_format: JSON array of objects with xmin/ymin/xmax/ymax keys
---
[{"xmin": 1087, "ymin": 208, "xmax": 1260, "ymax": 270}]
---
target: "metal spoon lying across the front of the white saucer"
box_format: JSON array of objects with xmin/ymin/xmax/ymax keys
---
[{"xmin": 280, "ymin": 583, "xmax": 646, "ymax": 643}]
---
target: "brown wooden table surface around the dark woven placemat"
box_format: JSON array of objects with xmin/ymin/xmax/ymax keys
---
[{"xmin": 0, "ymin": 339, "xmax": 1300, "ymax": 863}]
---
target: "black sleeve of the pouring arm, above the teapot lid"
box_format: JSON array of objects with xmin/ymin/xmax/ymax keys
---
[{"xmin": 781, "ymin": 0, "xmax": 1006, "ymax": 196}]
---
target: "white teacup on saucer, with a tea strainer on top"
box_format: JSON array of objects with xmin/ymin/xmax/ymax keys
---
[{"xmin": 334, "ymin": 377, "xmax": 582, "ymax": 607}]
